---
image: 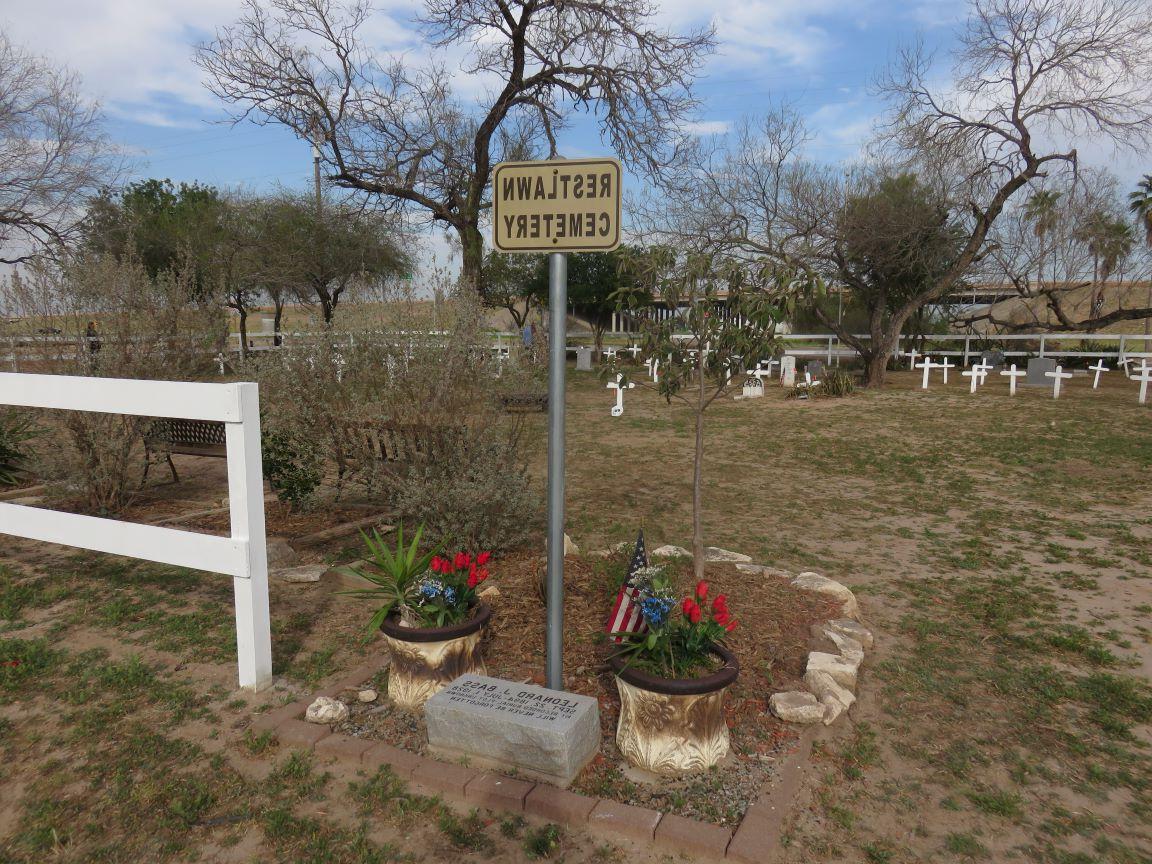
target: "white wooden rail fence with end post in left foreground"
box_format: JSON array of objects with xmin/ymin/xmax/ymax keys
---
[{"xmin": 0, "ymin": 372, "xmax": 272, "ymax": 688}]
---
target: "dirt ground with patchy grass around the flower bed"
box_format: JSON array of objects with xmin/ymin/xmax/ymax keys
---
[{"xmin": 0, "ymin": 370, "xmax": 1152, "ymax": 864}]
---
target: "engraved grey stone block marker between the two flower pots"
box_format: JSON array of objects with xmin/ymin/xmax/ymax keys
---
[{"xmin": 424, "ymin": 675, "xmax": 600, "ymax": 787}]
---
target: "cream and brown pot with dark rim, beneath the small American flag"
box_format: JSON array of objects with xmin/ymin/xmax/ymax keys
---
[{"xmin": 611, "ymin": 645, "xmax": 740, "ymax": 774}]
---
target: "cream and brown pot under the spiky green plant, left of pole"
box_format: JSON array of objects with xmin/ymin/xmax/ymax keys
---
[{"xmin": 380, "ymin": 602, "xmax": 492, "ymax": 711}]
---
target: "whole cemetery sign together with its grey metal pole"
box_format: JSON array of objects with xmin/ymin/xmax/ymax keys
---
[{"xmin": 492, "ymin": 159, "xmax": 623, "ymax": 690}]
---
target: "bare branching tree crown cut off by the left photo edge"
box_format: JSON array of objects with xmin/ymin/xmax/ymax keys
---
[{"xmin": 0, "ymin": 32, "xmax": 118, "ymax": 264}]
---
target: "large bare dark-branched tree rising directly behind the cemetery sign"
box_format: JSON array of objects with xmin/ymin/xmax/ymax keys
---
[{"xmin": 197, "ymin": 0, "xmax": 713, "ymax": 297}]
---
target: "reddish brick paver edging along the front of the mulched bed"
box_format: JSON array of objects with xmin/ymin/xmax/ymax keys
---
[{"xmin": 249, "ymin": 658, "xmax": 812, "ymax": 864}]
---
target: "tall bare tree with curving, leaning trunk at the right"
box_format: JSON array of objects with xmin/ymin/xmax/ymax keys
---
[{"xmin": 867, "ymin": 0, "xmax": 1152, "ymax": 384}]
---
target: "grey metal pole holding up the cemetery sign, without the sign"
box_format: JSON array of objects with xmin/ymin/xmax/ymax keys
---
[{"xmin": 545, "ymin": 252, "xmax": 568, "ymax": 690}]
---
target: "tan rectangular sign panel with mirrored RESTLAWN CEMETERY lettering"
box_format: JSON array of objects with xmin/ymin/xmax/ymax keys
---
[{"xmin": 492, "ymin": 159, "xmax": 622, "ymax": 252}]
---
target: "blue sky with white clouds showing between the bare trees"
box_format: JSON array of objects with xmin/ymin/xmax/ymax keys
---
[{"xmin": 0, "ymin": 0, "xmax": 1142, "ymax": 270}]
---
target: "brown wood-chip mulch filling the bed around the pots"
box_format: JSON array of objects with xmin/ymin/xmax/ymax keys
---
[{"xmin": 339, "ymin": 553, "xmax": 839, "ymax": 825}]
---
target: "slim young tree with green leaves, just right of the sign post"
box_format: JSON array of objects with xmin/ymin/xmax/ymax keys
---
[{"xmin": 609, "ymin": 253, "xmax": 794, "ymax": 579}]
